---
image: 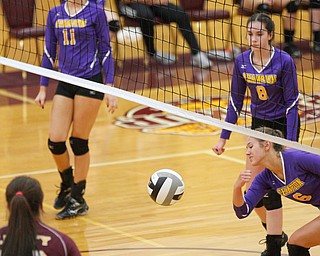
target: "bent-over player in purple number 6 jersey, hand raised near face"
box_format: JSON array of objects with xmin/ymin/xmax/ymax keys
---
[{"xmin": 233, "ymin": 127, "xmax": 320, "ymax": 256}]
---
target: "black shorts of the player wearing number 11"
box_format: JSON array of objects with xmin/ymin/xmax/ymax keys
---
[{"xmin": 55, "ymin": 73, "xmax": 104, "ymax": 100}]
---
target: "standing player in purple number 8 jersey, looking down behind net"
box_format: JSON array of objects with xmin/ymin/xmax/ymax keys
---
[{"xmin": 212, "ymin": 13, "xmax": 300, "ymax": 256}]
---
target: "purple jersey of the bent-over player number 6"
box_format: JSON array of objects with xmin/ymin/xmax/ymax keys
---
[{"xmin": 234, "ymin": 149, "xmax": 320, "ymax": 218}]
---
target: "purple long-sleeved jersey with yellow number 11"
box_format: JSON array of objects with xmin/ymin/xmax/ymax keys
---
[{"xmin": 40, "ymin": 2, "xmax": 114, "ymax": 86}]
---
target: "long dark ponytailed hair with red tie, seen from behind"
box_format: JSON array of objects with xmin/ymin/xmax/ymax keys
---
[{"xmin": 1, "ymin": 176, "xmax": 43, "ymax": 256}]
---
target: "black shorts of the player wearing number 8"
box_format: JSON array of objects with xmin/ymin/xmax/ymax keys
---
[{"xmin": 251, "ymin": 117, "xmax": 300, "ymax": 141}]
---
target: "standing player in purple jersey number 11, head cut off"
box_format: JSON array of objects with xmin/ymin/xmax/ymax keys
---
[{"xmin": 35, "ymin": 0, "xmax": 118, "ymax": 219}]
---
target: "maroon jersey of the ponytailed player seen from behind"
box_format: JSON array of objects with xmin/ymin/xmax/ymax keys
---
[{"xmin": 0, "ymin": 222, "xmax": 81, "ymax": 256}]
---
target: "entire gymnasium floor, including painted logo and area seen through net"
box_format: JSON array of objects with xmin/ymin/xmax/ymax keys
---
[{"xmin": 0, "ymin": 0, "xmax": 320, "ymax": 253}]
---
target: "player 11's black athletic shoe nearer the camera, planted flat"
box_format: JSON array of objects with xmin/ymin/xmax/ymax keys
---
[{"xmin": 56, "ymin": 197, "xmax": 89, "ymax": 220}]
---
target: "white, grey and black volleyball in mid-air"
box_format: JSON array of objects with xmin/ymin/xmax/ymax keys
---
[{"xmin": 148, "ymin": 169, "xmax": 184, "ymax": 206}]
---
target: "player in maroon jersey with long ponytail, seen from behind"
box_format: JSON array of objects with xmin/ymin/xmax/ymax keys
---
[{"xmin": 0, "ymin": 176, "xmax": 80, "ymax": 256}]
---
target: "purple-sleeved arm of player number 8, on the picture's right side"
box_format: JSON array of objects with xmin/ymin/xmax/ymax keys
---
[{"xmin": 282, "ymin": 58, "xmax": 299, "ymax": 141}]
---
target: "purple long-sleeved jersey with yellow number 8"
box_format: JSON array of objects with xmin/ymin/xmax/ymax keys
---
[{"xmin": 220, "ymin": 47, "xmax": 299, "ymax": 140}]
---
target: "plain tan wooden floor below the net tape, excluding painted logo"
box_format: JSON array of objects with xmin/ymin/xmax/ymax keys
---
[{"xmin": 0, "ymin": 76, "xmax": 320, "ymax": 256}]
